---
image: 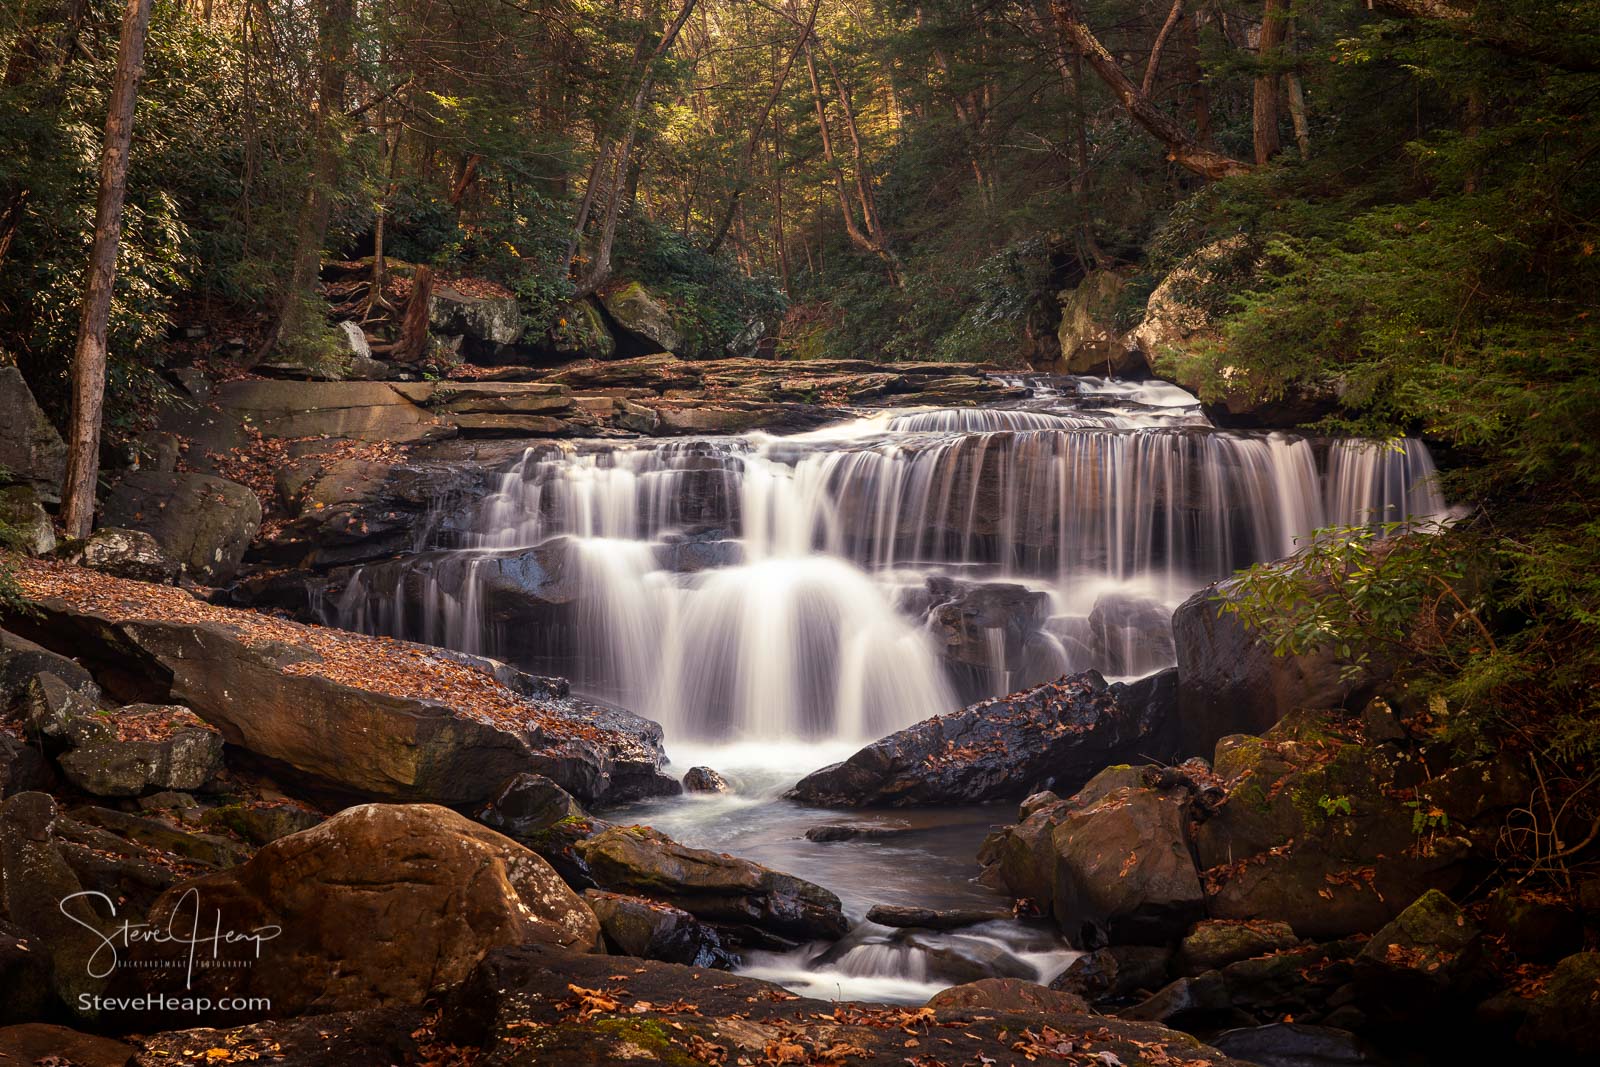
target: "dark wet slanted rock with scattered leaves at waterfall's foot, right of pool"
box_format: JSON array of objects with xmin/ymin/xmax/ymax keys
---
[{"xmin": 789, "ymin": 670, "xmax": 1178, "ymax": 808}]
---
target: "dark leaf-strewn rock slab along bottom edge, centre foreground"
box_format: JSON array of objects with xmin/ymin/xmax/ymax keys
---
[{"xmin": 445, "ymin": 945, "xmax": 1243, "ymax": 1067}]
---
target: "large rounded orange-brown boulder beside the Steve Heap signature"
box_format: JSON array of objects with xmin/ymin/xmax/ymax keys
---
[{"xmin": 137, "ymin": 805, "xmax": 600, "ymax": 1016}]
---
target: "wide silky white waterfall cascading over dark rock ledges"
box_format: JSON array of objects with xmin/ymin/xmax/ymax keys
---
[{"xmin": 322, "ymin": 379, "xmax": 1445, "ymax": 741}]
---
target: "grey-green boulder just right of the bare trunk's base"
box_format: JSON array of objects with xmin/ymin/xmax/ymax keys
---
[{"xmin": 101, "ymin": 470, "xmax": 261, "ymax": 585}]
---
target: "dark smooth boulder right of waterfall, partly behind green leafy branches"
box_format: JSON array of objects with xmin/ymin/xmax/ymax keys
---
[{"xmin": 1173, "ymin": 582, "xmax": 1360, "ymax": 753}]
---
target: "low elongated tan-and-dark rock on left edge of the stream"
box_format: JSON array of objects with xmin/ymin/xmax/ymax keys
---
[{"xmin": 574, "ymin": 827, "xmax": 850, "ymax": 941}]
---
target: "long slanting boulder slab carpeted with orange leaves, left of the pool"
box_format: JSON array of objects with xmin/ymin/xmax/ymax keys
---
[{"xmin": 18, "ymin": 565, "xmax": 678, "ymax": 806}]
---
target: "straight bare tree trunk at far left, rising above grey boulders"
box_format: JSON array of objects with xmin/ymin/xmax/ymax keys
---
[{"xmin": 61, "ymin": 0, "xmax": 150, "ymax": 537}]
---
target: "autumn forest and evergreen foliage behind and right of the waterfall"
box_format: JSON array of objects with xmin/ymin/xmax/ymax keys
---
[{"xmin": 0, "ymin": 0, "xmax": 1600, "ymax": 851}]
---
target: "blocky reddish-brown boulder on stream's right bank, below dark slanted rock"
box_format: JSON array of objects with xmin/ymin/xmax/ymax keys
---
[{"xmin": 1051, "ymin": 789, "xmax": 1205, "ymax": 947}]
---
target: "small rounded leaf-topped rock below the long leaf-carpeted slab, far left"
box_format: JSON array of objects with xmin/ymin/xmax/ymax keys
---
[{"xmin": 58, "ymin": 704, "xmax": 222, "ymax": 797}]
